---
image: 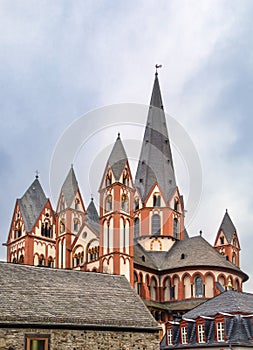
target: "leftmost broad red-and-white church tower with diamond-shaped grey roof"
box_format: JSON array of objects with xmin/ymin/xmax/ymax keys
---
[{"xmin": 5, "ymin": 176, "xmax": 56, "ymax": 267}]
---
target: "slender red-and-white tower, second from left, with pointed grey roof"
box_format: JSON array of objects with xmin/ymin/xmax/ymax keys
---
[{"xmin": 56, "ymin": 166, "xmax": 85, "ymax": 269}]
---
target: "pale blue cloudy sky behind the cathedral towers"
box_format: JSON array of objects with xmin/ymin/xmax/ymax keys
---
[{"xmin": 0, "ymin": 0, "xmax": 253, "ymax": 292}]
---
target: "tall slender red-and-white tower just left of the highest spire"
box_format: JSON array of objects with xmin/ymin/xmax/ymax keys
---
[{"xmin": 99, "ymin": 134, "xmax": 134, "ymax": 285}]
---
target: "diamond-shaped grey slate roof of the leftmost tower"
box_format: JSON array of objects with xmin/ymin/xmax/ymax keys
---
[{"xmin": 18, "ymin": 178, "xmax": 47, "ymax": 232}]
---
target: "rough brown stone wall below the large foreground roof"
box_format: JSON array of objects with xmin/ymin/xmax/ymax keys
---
[{"xmin": 0, "ymin": 328, "xmax": 160, "ymax": 350}]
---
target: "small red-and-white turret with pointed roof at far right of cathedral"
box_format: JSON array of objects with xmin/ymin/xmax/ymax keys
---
[{"xmin": 214, "ymin": 210, "xmax": 241, "ymax": 268}]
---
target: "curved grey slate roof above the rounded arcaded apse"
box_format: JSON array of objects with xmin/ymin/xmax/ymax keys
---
[{"xmin": 134, "ymin": 236, "xmax": 248, "ymax": 281}]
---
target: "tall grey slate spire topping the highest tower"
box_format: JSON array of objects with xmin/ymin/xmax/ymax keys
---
[{"xmin": 135, "ymin": 74, "xmax": 176, "ymax": 201}]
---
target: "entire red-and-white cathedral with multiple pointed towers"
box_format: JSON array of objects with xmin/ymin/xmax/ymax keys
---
[{"xmin": 5, "ymin": 72, "xmax": 248, "ymax": 323}]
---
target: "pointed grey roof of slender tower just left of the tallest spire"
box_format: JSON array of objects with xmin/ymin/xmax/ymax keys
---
[{"xmin": 108, "ymin": 134, "xmax": 127, "ymax": 181}]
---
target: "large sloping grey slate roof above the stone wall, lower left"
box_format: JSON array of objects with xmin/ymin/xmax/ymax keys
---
[{"xmin": 0, "ymin": 262, "xmax": 158, "ymax": 328}]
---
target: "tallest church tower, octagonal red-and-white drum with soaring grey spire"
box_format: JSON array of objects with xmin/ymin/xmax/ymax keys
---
[{"xmin": 134, "ymin": 72, "xmax": 184, "ymax": 250}]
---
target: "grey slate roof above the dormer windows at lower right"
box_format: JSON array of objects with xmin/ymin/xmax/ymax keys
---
[{"xmin": 184, "ymin": 290, "xmax": 253, "ymax": 319}]
